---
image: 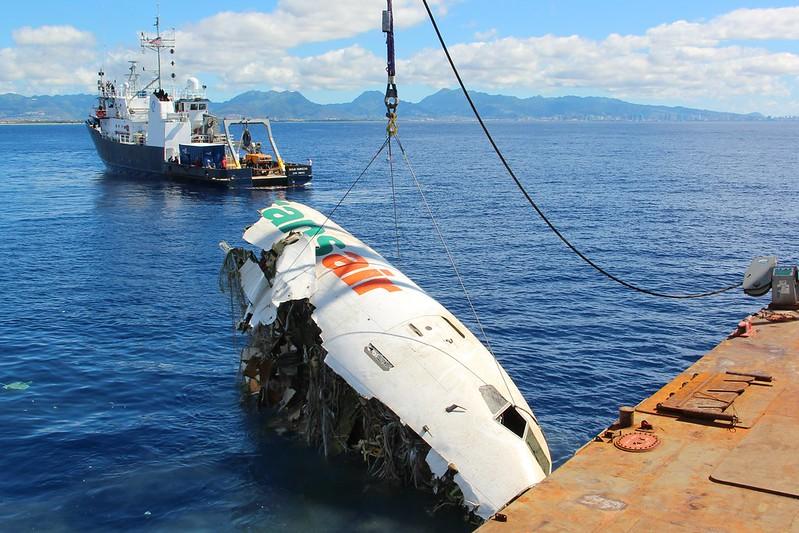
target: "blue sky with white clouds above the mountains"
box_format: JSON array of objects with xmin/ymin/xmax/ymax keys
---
[{"xmin": 0, "ymin": 0, "xmax": 799, "ymax": 116}]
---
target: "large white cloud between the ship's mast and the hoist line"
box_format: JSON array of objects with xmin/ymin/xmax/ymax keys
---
[{"xmin": 124, "ymin": 0, "xmax": 456, "ymax": 91}]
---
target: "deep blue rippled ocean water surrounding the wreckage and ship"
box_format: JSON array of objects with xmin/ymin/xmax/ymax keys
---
[{"xmin": 0, "ymin": 122, "xmax": 799, "ymax": 531}]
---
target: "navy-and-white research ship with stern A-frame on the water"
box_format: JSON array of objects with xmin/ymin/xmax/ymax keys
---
[{"xmin": 86, "ymin": 18, "xmax": 313, "ymax": 187}]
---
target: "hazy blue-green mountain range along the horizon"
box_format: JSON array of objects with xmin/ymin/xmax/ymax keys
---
[{"xmin": 0, "ymin": 89, "xmax": 766, "ymax": 122}]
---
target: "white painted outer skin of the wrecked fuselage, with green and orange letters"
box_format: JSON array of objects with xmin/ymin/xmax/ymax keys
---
[{"xmin": 238, "ymin": 201, "xmax": 551, "ymax": 518}]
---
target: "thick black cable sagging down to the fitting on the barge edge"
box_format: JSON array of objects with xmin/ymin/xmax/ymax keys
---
[{"xmin": 422, "ymin": 0, "xmax": 742, "ymax": 299}]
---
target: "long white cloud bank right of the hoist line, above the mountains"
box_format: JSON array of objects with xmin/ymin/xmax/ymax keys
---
[{"xmin": 399, "ymin": 8, "xmax": 799, "ymax": 111}]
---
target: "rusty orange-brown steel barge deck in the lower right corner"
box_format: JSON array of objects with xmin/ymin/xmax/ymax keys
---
[{"xmin": 480, "ymin": 311, "xmax": 799, "ymax": 533}]
